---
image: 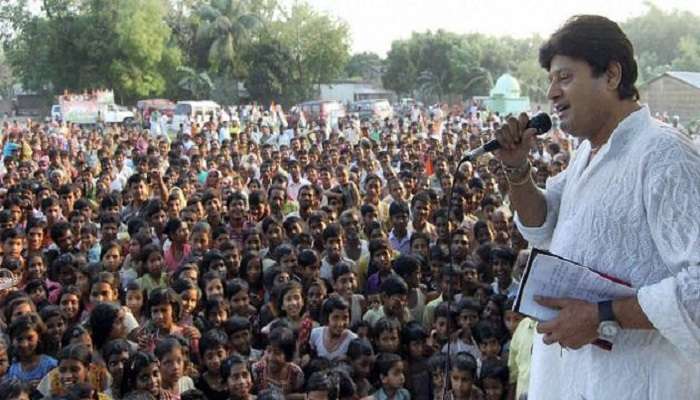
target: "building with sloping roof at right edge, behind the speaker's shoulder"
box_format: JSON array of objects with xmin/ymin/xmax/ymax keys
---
[{"xmin": 639, "ymin": 71, "xmax": 700, "ymax": 125}]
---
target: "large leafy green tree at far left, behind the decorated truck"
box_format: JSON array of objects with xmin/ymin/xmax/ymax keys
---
[{"xmin": 5, "ymin": 0, "xmax": 180, "ymax": 102}]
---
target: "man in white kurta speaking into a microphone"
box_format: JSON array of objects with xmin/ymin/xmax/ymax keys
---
[{"xmin": 496, "ymin": 15, "xmax": 700, "ymax": 400}]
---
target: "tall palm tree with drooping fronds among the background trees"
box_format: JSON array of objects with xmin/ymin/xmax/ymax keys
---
[{"xmin": 196, "ymin": 0, "xmax": 261, "ymax": 73}]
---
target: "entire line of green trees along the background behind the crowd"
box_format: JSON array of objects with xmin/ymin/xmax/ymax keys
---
[{"xmin": 0, "ymin": 0, "xmax": 700, "ymax": 105}]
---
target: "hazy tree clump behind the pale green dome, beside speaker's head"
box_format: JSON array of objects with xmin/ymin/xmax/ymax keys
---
[{"xmin": 383, "ymin": 30, "xmax": 546, "ymax": 101}]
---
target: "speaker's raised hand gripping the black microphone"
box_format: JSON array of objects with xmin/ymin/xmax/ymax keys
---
[{"xmin": 496, "ymin": 113, "xmax": 537, "ymax": 167}]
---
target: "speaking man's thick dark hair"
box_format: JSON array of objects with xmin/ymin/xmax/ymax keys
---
[{"xmin": 539, "ymin": 15, "xmax": 639, "ymax": 100}]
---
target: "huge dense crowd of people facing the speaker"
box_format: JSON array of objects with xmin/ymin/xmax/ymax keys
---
[{"xmin": 0, "ymin": 103, "xmax": 576, "ymax": 400}]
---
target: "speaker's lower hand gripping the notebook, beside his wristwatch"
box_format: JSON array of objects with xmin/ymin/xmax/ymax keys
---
[{"xmin": 535, "ymin": 297, "xmax": 599, "ymax": 349}]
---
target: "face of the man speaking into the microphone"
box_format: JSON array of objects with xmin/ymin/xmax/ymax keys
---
[{"xmin": 547, "ymin": 55, "xmax": 617, "ymax": 138}]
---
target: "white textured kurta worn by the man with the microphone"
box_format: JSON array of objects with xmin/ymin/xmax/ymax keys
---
[{"xmin": 516, "ymin": 107, "xmax": 700, "ymax": 400}]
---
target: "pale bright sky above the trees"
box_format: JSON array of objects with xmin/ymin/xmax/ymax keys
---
[{"xmin": 300, "ymin": 0, "xmax": 700, "ymax": 56}]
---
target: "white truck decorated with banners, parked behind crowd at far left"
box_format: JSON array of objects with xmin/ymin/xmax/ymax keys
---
[{"xmin": 52, "ymin": 90, "xmax": 136, "ymax": 125}]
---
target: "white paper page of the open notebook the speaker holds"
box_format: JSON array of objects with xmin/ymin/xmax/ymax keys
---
[{"xmin": 518, "ymin": 253, "xmax": 637, "ymax": 321}]
